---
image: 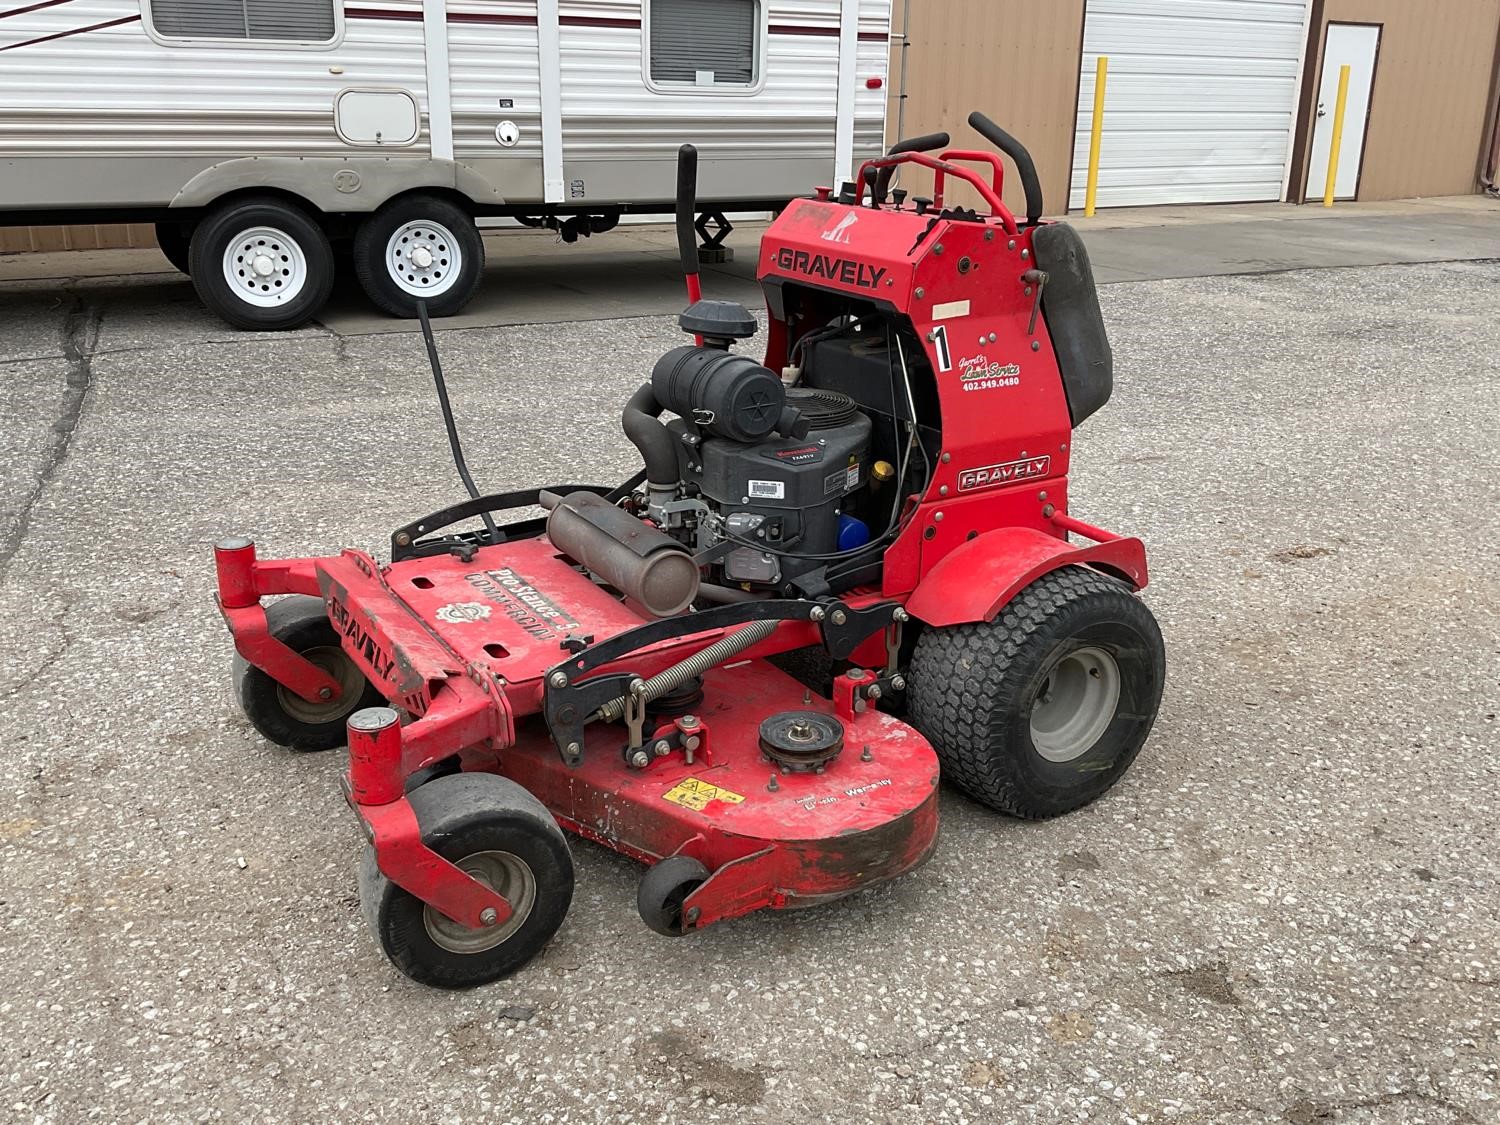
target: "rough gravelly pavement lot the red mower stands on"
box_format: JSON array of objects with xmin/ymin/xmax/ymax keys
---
[{"xmin": 0, "ymin": 250, "xmax": 1500, "ymax": 1125}]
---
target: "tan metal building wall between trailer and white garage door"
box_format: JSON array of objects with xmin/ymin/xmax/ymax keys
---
[{"xmin": 885, "ymin": 0, "xmax": 1085, "ymax": 215}]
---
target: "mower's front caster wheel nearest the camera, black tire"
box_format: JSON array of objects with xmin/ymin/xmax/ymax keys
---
[{"xmin": 360, "ymin": 773, "xmax": 573, "ymax": 989}]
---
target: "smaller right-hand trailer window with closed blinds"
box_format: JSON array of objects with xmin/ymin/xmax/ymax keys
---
[{"xmin": 650, "ymin": 0, "xmax": 761, "ymax": 86}]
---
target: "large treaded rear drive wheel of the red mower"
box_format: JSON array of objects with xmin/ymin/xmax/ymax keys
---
[{"xmin": 908, "ymin": 567, "xmax": 1167, "ymax": 819}]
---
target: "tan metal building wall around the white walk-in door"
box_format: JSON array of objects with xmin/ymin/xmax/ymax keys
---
[{"xmin": 1290, "ymin": 0, "xmax": 1500, "ymax": 201}]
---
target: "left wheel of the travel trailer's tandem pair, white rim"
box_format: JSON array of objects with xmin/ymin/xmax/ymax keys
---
[{"xmin": 188, "ymin": 198, "xmax": 333, "ymax": 330}]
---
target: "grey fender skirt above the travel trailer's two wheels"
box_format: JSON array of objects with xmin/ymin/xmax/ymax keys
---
[{"xmin": 170, "ymin": 156, "xmax": 506, "ymax": 213}]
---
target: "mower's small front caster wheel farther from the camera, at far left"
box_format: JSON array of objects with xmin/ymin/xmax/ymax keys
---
[{"xmin": 234, "ymin": 594, "xmax": 386, "ymax": 750}]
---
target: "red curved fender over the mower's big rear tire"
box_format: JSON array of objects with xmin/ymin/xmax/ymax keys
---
[{"xmin": 906, "ymin": 528, "xmax": 1146, "ymax": 626}]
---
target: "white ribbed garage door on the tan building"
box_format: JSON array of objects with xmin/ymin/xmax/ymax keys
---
[{"xmin": 1070, "ymin": 0, "xmax": 1308, "ymax": 209}]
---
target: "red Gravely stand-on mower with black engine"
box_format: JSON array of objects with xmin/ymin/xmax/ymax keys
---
[{"xmin": 216, "ymin": 114, "xmax": 1166, "ymax": 987}]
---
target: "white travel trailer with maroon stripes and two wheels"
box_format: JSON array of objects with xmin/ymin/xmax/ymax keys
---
[{"xmin": 0, "ymin": 0, "xmax": 890, "ymax": 329}]
